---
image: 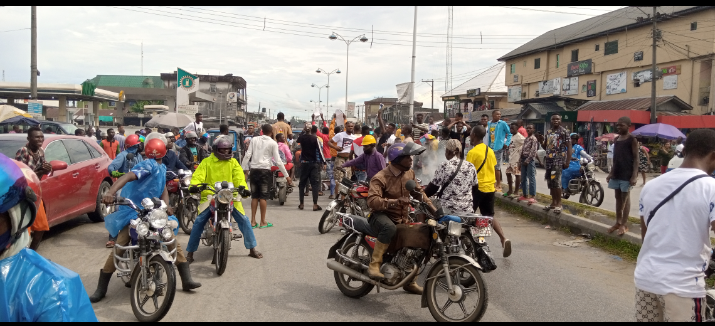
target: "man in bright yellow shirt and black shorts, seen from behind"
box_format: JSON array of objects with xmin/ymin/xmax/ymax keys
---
[{"xmin": 467, "ymin": 126, "xmax": 511, "ymax": 257}]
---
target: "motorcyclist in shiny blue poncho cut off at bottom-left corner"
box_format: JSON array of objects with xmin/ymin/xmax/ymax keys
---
[{"xmin": 0, "ymin": 154, "xmax": 97, "ymax": 322}]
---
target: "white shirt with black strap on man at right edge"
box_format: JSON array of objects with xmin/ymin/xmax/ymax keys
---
[{"xmin": 634, "ymin": 168, "xmax": 715, "ymax": 298}]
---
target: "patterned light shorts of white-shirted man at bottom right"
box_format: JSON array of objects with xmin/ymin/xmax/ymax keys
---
[{"xmin": 635, "ymin": 288, "xmax": 705, "ymax": 322}]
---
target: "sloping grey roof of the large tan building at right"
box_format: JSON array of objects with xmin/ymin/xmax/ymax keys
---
[{"xmin": 497, "ymin": 6, "xmax": 712, "ymax": 61}]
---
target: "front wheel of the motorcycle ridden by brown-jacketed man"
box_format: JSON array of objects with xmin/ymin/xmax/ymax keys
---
[{"xmin": 425, "ymin": 258, "xmax": 489, "ymax": 322}]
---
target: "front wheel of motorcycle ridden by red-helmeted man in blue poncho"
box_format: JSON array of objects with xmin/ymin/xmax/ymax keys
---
[{"xmin": 130, "ymin": 256, "xmax": 176, "ymax": 323}]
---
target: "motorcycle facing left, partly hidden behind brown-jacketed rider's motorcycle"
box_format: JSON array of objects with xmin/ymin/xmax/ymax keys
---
[{"xmin": 318, "ymin": 177, "xmax": 370, "ymax": 234}]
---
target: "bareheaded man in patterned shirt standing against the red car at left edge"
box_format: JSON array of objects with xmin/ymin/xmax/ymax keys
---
[{"xmin": 15, "ymin": 127, "xmax": 52, "ymax": 250}]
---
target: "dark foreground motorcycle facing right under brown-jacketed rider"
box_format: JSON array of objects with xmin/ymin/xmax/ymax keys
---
[{"xmin": 327, "ymin": 181, "xmax": 488, "ymax": 322}]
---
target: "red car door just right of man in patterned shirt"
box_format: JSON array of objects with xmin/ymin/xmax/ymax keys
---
[{"xmin": 41, "ymin": 140, "xmax": 75, "ymax": 225}]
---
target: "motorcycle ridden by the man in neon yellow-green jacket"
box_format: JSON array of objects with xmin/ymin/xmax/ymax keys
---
[{"xmin": 189, "ymin": 181, "xmax": 251, "ymax": 275}]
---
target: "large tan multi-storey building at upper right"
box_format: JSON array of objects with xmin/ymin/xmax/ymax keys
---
[{"xmin": 498, "ymin": 6, "xmax": 715, "ymax": 127}]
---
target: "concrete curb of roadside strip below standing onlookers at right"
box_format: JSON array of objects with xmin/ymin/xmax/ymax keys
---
[{"xmin": 495, "ymin": 196, "xmax": 642, "ymax": 246}]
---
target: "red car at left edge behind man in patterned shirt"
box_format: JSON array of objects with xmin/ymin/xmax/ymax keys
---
[{"xmin": 0, "ymin": 134, "xmax": 112, "ymax": 227}]
